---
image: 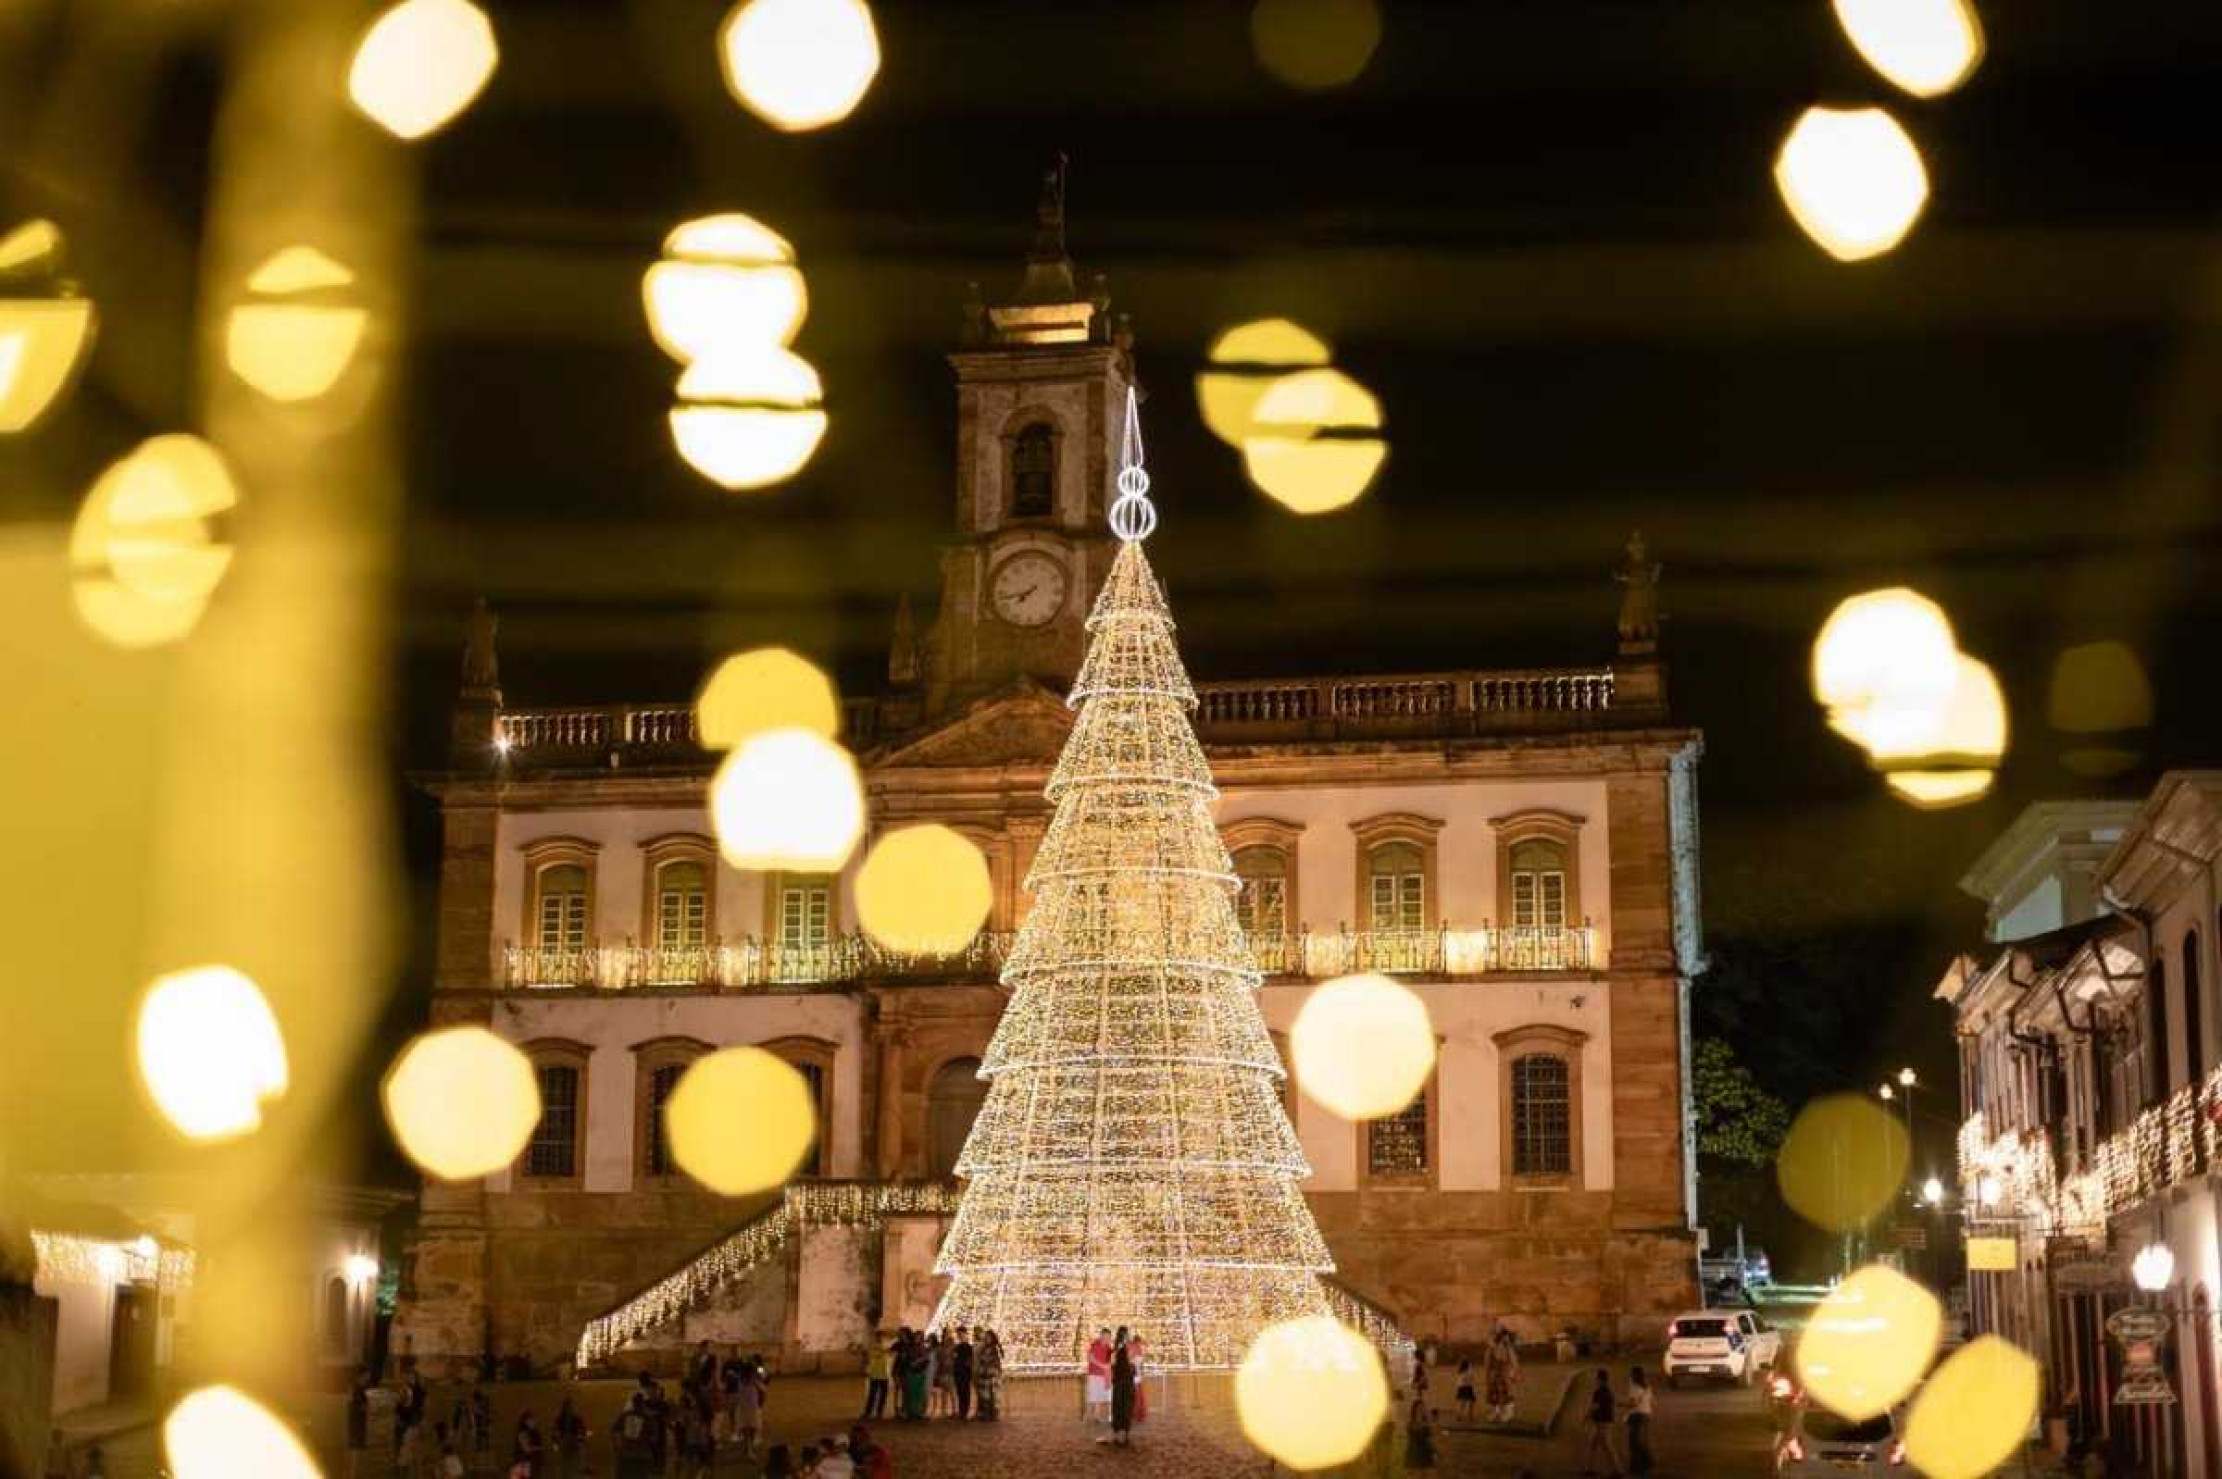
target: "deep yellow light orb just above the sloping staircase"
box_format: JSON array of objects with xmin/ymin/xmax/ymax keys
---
[{"xmin": 664, "ymin": 1048, "xmax": 818, "ymax": 1197}]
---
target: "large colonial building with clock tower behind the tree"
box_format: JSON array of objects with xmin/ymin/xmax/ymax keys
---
[{"xmin": 396, "ymin": 180, "xmax": 1702, "ymax": 1368}]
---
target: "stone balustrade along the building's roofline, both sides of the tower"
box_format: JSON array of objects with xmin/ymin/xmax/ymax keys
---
[{"xmin": 493, "ymin": 668, "xmax": 1655, "ymax": 766}]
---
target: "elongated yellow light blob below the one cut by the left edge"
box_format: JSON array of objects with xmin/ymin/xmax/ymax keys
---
[{"xmin": 69, "ymin": 433, "xmax": 238, "ymax": 648}]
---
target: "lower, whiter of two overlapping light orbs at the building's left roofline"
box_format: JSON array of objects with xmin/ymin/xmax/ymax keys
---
[{"xmin": 709, "ymin": 728, "xmax": 864, "ymax": 873}]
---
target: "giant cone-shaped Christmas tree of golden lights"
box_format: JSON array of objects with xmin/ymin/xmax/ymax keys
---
[{"xmin": 935, "ymin": 391, "xmax": 1333, "ymax": 1370}]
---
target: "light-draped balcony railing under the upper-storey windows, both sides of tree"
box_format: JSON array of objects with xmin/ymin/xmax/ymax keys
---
[{"xmin": 502, "ymin": 924, "xmax": 1598, "ymax": 990}]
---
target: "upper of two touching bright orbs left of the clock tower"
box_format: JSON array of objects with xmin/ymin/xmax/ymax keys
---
[{"xmin": 640, "ymin": 213, "xmax": 809, "ymax": 364}]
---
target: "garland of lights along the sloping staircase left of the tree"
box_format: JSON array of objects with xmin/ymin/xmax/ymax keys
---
[{"xmin": 578, "ymin": 1181, "xmax": 958, "ymax": 1370}]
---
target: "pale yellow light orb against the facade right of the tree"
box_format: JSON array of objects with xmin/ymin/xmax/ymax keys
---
[{"xmin": 1289, "ymin": 975, "xmax": 1435, "ymax": 1119}]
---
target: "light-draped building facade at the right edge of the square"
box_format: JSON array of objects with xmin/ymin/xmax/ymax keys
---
[{"xmin": 1938, "ymin": 771, "xmax": 2222, "ymax": 1479}]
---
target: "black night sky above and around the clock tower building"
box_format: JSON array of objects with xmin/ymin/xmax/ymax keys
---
[{"xmin": 0, "ymin": 0, "xmax": 2222, "ymax": 1216}]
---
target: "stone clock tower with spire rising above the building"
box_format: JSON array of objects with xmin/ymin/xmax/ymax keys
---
[{"xmin": 927, "ymin": 158, "xmax": 1133, "ymax": 717}]
